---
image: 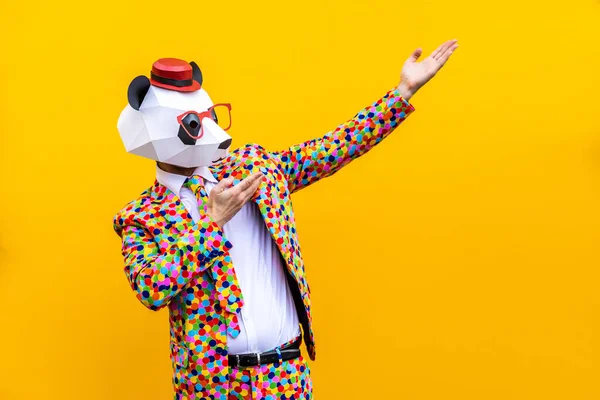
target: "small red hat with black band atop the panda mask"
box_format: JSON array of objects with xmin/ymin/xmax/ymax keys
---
[{"xmin": 150, "ymin": 58, "xmax": 202, "ymax": 92}]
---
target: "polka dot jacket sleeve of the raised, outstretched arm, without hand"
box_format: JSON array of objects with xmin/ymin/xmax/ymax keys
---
[{"xmin": 271, "ymin": 89, "xmax": 414, "ymax": 193}]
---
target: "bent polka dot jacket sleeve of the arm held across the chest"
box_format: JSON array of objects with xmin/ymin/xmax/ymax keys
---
[{"xmin": 115, "ymin": 193, "xmax": 232, "ymax": 310}]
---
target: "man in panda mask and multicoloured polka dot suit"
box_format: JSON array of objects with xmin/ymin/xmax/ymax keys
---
[{"xmin": 114, "ymin": 40, "xmax": 458, "ymax": 400}]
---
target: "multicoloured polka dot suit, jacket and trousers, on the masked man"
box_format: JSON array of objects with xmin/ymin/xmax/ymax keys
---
[{"xmin": 114, "ymin": 90, "xmax": 414, "ymax": 400}]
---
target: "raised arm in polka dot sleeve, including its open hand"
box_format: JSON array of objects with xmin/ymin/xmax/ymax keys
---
[{"xmin": 272, "ymin": 40, "xmax": 458, "ymax": 193}]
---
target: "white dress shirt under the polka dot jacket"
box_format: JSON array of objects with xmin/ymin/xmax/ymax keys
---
[{"xmin": 156, "ymin": 166, "xmax": 300, "ymax": 354}]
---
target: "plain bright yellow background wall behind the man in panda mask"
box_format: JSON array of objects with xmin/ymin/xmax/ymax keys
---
[{"xmin": 0, "ymin": 0, "xmax": 600, "ymax": 400}]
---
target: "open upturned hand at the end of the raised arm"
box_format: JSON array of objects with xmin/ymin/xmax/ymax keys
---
[{"xmin": 398, "ymin": 39, "xmax": 458, "ymax": 100}]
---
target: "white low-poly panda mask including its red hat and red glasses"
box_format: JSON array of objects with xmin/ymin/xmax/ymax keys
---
[{"xmin": 117, "ymin": 58, "xmax": 231, "ymax": 167}]
